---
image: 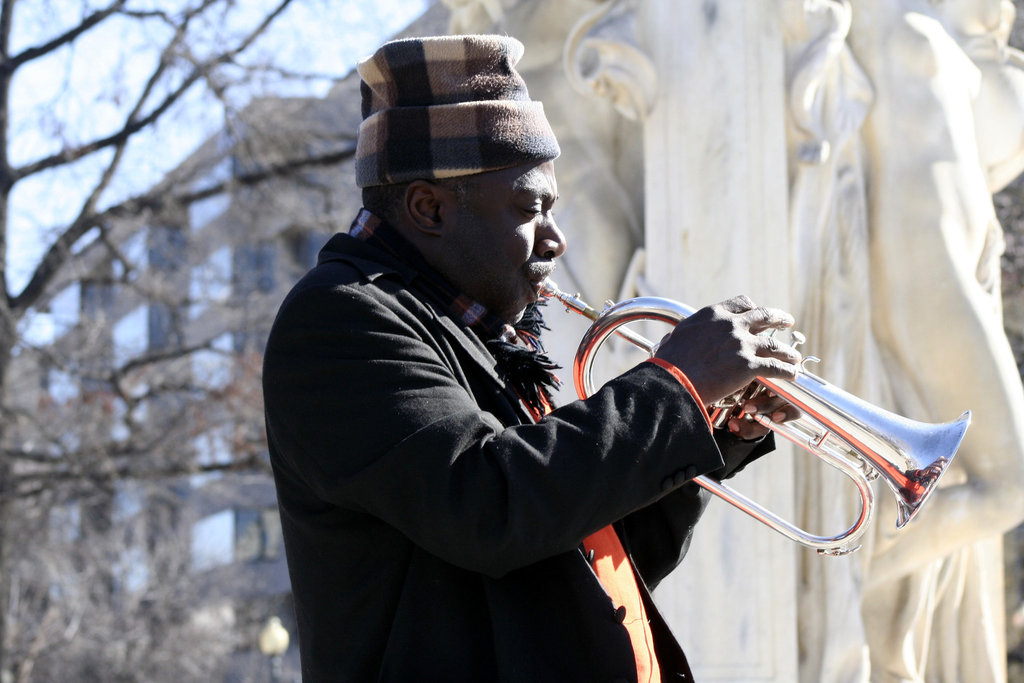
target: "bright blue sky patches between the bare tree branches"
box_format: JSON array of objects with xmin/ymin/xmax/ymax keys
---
[{"xmin": 7, "ymin": 0, "xmax": 429, "ymax": 292}]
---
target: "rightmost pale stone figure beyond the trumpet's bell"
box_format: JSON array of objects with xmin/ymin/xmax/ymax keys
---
[{"xmin": 849, "ymin": 0, "xmax": 1024, "ymax": 682}]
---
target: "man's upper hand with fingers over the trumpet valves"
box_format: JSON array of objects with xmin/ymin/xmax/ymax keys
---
[{"xmin": 654, "ymin": 296, "xmax": 803, "ymax": 404}]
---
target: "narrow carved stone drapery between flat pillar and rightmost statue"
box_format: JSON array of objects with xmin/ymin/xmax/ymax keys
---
[{"xmin": 782, "ymin": 0, "xmax": 876, "ymax": 682}]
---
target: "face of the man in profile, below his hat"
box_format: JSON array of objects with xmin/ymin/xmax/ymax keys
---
[{"xmin": 443, "ymin": 162, "xmax": 565, "ymax": 323}]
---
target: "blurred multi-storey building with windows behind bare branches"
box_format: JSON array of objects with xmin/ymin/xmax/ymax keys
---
[{"xmin": 1, "ymin": 6, "xmax": 447, "ymax": 682}]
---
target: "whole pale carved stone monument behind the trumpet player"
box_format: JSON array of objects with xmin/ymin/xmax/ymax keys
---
[{"xmin": 436, "ymin": 0, "xmax": 1024, "ymax": 683}]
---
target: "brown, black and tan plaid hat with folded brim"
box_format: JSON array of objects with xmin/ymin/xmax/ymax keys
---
[{"xmin": 355, "ymin": 36, "xmax": 559, "ymax": 187}]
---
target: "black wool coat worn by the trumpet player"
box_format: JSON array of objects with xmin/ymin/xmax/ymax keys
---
[{"xmin": 263, "ymin": 234, "xmax": 770, "ymax": 683}]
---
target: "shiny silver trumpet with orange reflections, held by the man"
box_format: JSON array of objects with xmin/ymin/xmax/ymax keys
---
[{"xmin": 542, "ymin": 280, "xmax": 971, "ymax": 555}]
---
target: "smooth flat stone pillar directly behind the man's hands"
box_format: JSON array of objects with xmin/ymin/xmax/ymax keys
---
[{"xmin": 638, "ymin": 2, "xmax": 802, "ymax": 681}]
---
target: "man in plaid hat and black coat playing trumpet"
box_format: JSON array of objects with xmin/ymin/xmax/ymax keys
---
[{"xmin": 264, "ymin": 36, "xmax": 801, "ymax": 682}]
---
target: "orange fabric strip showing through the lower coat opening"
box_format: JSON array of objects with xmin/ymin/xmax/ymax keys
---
[{"xmin": 583, "ymin": 526, "xmax": 662, "ymax": 683}]
